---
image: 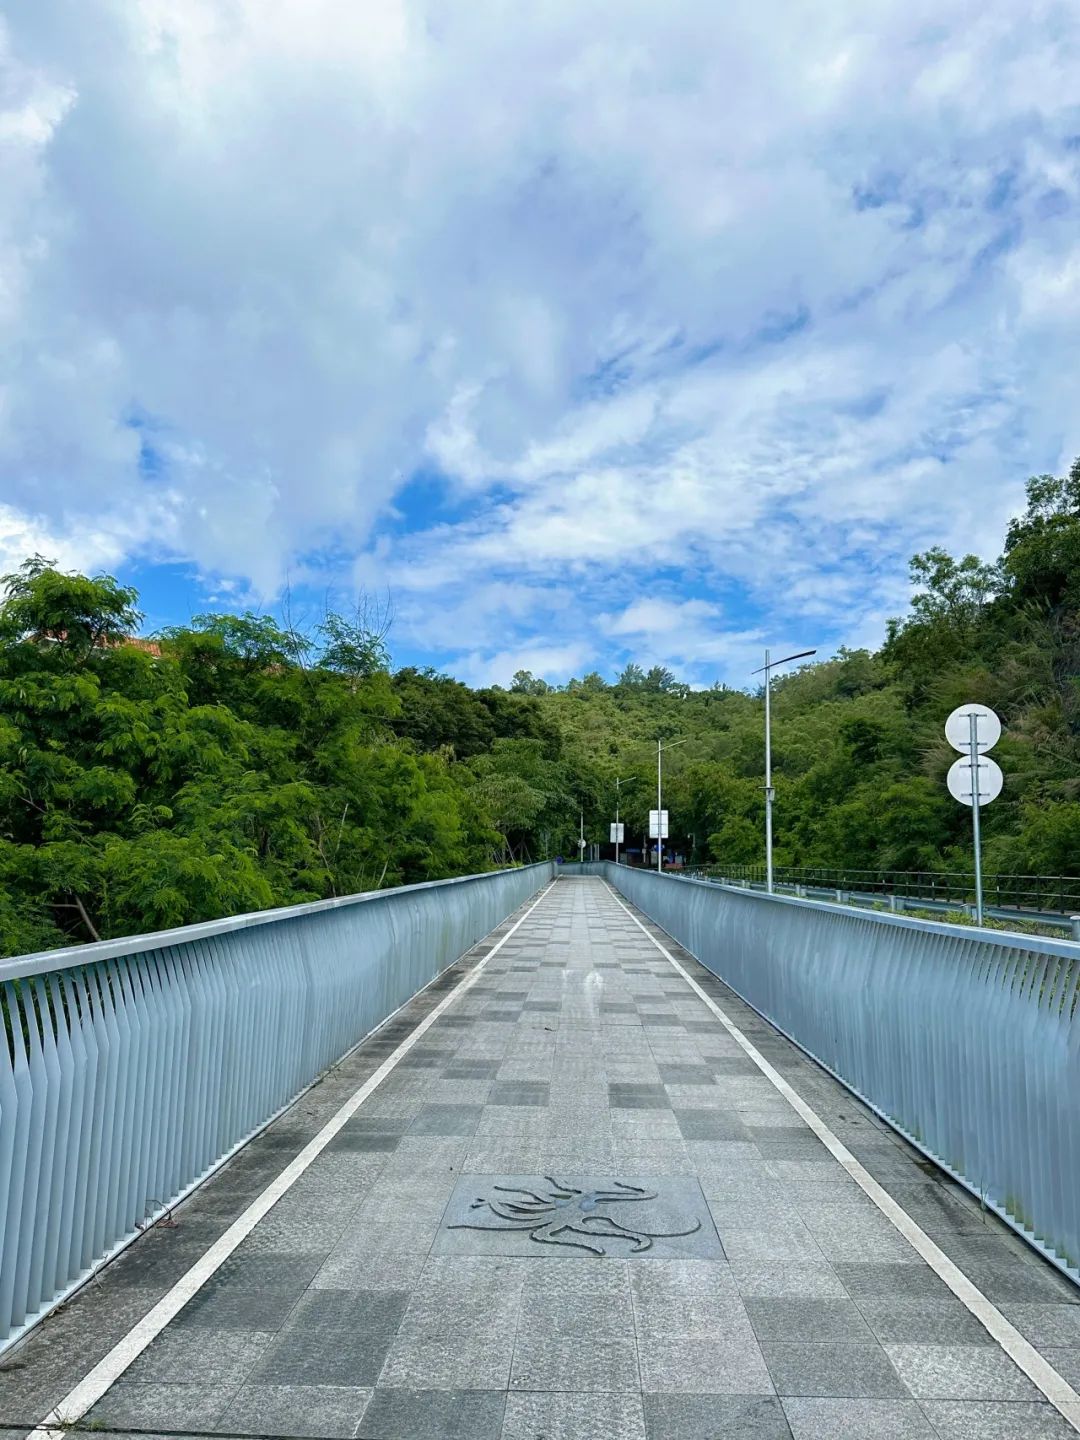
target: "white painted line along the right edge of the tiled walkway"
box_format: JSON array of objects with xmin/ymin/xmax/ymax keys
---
[{"xmin": 602, "ymin": 880, "xmax": 1080, "ymax": 1433}]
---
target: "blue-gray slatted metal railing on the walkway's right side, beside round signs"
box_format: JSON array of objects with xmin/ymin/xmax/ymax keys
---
[{"xmin": 584, "ymin": 863, "xmax": 1080, "ymax": 1280}]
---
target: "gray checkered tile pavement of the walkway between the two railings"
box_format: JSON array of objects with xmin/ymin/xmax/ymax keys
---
[{"xmin": 0, "ymin": 880, "xmax": 1080, "ymax": 1440}]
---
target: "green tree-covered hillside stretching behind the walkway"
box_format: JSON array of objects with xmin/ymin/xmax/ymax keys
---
[{"xmin": 0, "ymin": 461, "xmax": 1080, "ymax": 955}]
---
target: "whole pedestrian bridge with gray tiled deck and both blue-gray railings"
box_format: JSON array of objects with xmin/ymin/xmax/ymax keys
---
[{"xmin": 0, "ymin": 865, "xmax": 1080, "ymax": 1440}]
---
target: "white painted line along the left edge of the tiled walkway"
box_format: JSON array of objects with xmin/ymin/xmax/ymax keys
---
[{"xmin": 26, "ymin": 880, "xmax": 556, "ymax": 1440}]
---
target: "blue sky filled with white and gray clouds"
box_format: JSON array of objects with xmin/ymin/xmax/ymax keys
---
[{"xmin": 0, "ymin": 0, "xmax": 1080, "ymax": 684}]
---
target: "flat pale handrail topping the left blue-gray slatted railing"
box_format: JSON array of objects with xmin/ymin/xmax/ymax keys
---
[{"xmin": 0, "ymin": 860, "xmax": 550, "ymax": 984}]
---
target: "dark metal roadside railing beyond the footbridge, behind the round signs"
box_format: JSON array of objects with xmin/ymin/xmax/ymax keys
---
[{"xmin": 693, "ymin": 865, "xmax": 1080, "ymax": 917}]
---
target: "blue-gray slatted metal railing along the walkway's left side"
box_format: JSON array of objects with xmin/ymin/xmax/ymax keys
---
[{"xmin": 0, "ymin": 863, "xmax": 552, "ymax": 1346}]
